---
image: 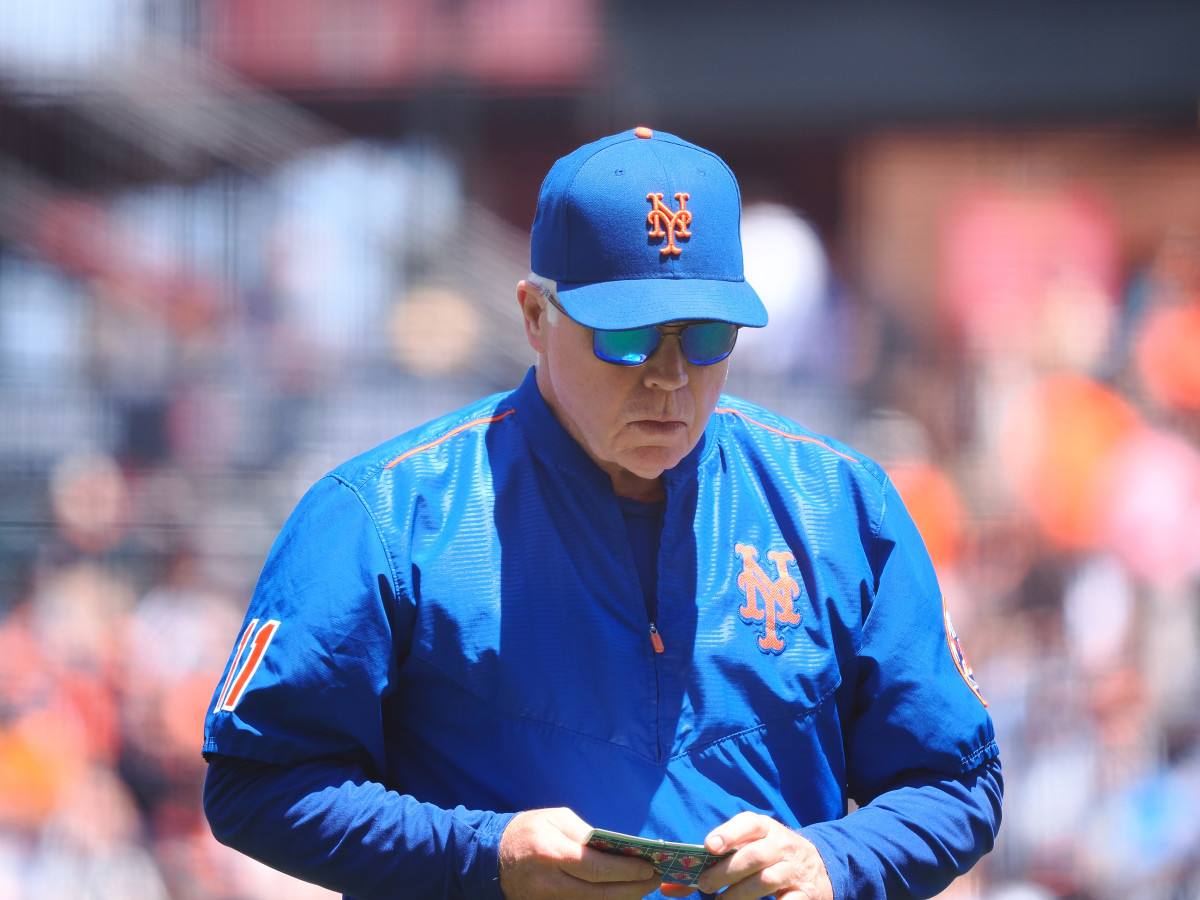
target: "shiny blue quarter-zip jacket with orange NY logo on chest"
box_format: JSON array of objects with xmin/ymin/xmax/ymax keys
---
[{"xmin": 204, "ymin": 372, "xmax": 1000, "ymax": 896}]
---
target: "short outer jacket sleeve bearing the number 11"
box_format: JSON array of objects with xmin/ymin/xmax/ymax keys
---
[{"xmin": 203, "ymin": 476, "xmax": 403, "ymax": 779}]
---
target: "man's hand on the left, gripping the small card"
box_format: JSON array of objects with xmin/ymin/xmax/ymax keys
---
[{"xmin": 500, "ymin": 809, "xmax": 660, "ymax": 900}]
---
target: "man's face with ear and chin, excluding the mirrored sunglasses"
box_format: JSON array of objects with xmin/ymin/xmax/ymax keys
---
[{"xmin": 517, "ymin": 282, "xmax": 730, "ymax": 499}]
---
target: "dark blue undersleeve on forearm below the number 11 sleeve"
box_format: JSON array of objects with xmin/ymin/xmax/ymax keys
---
[{"xmin": 204, "ymin": 754, "xmax": 512, "ymax": 900}]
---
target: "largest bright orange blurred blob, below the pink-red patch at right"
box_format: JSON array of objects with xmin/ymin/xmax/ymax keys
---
[{"xmin": 1004, "ymin": 374, "xmax": 1140, "ymax": 550}]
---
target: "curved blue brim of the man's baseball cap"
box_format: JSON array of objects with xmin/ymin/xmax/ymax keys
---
[{"xmin": 558, "ymin": 278, "xmax": 767, "ymax": 330}]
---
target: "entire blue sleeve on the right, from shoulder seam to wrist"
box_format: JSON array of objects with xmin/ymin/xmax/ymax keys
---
[{"xmin": 803, "ymin": 479, "xmax": 1003, "ymax": 900}]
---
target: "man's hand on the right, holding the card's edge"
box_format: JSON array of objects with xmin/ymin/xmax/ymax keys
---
[{"xmin": 662, "ymin": 812, "xmax": 833, "ymax": 900}]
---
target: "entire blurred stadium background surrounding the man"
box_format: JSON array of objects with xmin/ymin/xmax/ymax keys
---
[{"xmin": 0, "ymin": 0, "xmax": 1200, "ymax": 900}]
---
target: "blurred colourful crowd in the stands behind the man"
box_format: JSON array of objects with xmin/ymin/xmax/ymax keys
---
[{"xmin": 0, "ymin": 128, "xmax": 1200, "ymax": 900}]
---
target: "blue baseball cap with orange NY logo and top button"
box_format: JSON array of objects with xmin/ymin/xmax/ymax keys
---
[{"xmin": 529, "ymin": 127, "xmax": 767, "ymax": 330}]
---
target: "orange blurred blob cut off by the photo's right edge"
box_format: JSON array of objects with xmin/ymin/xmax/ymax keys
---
[{"xmin": 1135, "ymin": 306, "xmax": 1200, "ymax": 412}]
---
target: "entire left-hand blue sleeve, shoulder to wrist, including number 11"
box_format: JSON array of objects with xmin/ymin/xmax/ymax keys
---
[{"xmin": 203, "ymin": 476, "xmax": 511, "ymax": 900}]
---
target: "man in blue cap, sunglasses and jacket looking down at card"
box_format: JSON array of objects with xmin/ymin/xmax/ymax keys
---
[{"xmin": 204, "ymin": 128, "xmax": 1001, "ymax": 900}]
